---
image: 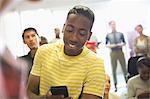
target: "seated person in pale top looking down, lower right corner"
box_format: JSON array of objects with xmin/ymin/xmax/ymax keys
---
[{"xmin": 128, "ymin": 57, "xmax": 150, "ymax": 99}]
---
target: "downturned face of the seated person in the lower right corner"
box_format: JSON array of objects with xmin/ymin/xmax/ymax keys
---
[{"xmin": 139, "ymin": 64, "xmax": 150, "ymax": 81}]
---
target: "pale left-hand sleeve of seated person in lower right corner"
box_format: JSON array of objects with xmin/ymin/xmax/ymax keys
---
[{"xmin": 127, "ymin": 80, "xmax": 136, "ymax": 99}]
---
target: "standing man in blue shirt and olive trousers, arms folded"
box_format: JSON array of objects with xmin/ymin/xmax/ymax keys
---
[{"xmin": 106, "ymin": 21, "xmax": 127, "ymax": 91}]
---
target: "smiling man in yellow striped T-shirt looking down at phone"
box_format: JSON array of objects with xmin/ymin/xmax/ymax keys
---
[{"xmin": 27, "ymin": 6, "xmax": 105, "ymax": 99}]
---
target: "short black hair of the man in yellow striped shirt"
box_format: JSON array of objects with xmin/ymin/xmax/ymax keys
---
[{"xmin": 67, "ymin": 5, "xmax": 95, "ymax": 30}]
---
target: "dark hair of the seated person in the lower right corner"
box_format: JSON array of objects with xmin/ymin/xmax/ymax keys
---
[{"xmin": 136, "ymin": 57, "xmax": 150, "ymax": 69}]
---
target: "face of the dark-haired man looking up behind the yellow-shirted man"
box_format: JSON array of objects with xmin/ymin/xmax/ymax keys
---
[{"xmin": 24, "ymin": 31, "xmax": 38, "ymax": 49}]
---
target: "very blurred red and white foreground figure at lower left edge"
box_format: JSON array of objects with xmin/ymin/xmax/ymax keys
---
[{"xmin": 0, "ymin": 48, "xmax": 27, "ymax": 99}]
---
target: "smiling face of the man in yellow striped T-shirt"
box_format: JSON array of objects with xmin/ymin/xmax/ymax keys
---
[{"xmin": 63, "ymin": 14, "xmax": 91, "ymax": 56}]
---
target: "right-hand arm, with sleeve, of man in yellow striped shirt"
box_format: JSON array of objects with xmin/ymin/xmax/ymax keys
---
[{"xmin": 81, "ymin": 58, "xmax": 105, "ymax": 99}]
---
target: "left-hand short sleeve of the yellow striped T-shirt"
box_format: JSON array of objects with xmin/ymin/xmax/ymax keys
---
[{"xmin": 31, "ymin": 48, "xmax": 42, "ymax": 76}]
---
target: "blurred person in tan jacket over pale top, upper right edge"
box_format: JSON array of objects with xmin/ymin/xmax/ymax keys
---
[{"xmin": 128, "ymin": 24, "xmax": 150, "ymax": 78}]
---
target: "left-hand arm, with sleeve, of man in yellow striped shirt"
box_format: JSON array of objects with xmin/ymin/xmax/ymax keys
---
[{"xmin": 27, "ymin": 45, "xmax": 70, "ymax": 99}]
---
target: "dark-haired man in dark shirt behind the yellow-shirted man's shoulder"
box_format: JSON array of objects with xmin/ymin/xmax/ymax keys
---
[{"xmin": 19, "ymin": 27, "xmax": 39, "ymax": 76}]
